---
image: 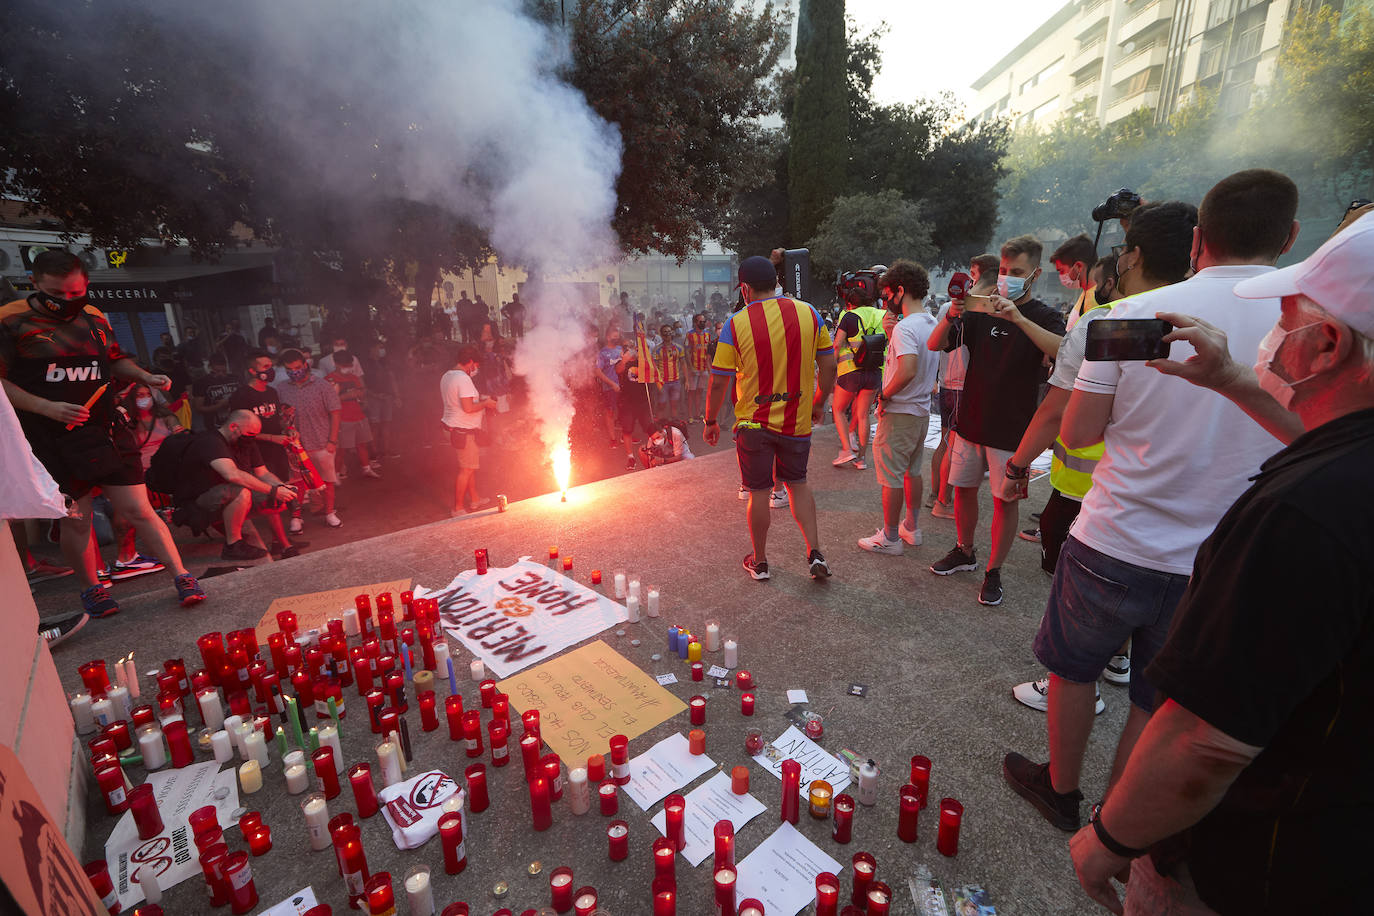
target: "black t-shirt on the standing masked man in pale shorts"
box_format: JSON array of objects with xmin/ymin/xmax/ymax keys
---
[{"xmin": 945, "ymin": 299, "xmax": 1063, "ymax": 450}]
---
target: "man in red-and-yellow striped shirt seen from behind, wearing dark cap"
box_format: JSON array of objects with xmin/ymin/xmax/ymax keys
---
[{"xmin": 703, "ymin": 255, "xmax": 835, "ymax": 580}]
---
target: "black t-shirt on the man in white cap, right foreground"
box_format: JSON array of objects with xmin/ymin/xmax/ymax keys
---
[{"xmin": 1145, "ymin": 411, "xmax": 1374, "ymax": 913}]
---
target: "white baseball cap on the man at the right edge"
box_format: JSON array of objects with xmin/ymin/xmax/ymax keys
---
[{"xmin": 1235, "ymin": 213, "xmax": 1374, "ymax": 338}]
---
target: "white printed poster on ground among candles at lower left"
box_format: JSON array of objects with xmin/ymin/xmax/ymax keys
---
[{"xmin": 104, "ymin": 761, "xmax": 239, "ymax": 909}]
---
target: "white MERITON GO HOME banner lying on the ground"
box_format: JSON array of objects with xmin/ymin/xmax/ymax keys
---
[{"xmin": 415, "ymin": 558, "xmax": 629, "ymax": 677}]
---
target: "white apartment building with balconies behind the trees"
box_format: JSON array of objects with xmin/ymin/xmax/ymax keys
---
[{"xmin": 973, "ymin": 0, "xmax": 1341, "ymax": 129}]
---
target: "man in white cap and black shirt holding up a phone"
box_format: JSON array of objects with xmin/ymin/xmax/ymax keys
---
[{"xmin": 1070, "ymin": 214, "xmax": 1374, "ymax": 913}]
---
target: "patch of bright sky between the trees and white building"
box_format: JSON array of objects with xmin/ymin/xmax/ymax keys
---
[{"xmin": 845, "ymin": 0, "xmax": 1068, "ymax": 104}]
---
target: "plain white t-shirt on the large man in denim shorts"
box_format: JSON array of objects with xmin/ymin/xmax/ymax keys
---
[{"xmin": 1069, "ymin": 265, "xmax": 1282, "ymax": 575}]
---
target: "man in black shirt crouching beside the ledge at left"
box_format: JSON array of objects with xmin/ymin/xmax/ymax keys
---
[{"xmin": 176, "ymin": 411, "xmax": 300, "ymax": 560}]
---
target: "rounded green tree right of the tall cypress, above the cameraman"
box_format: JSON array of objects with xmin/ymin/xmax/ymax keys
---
[{"xmin": 811, "ymin": 188, "xmax": 936, "ymax": 276}]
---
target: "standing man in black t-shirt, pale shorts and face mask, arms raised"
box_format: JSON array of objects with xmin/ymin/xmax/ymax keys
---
[{"xmin": 927, "ymin": 235, "xmax": 1063, "ymax": 606}]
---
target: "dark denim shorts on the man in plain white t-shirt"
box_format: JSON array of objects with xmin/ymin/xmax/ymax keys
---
[{"xmin": 1035, "ymin": 534, "xmax": 1189, "ymax": 711}]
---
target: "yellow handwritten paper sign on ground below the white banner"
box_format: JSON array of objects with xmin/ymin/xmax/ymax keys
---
[{"xmin": 500, "ymin": 640, "xmax": 687, "ymax": 765}]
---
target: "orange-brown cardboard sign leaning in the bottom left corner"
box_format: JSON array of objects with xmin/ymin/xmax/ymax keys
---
[{"xmin": 0, "ymin": 744, "xmax": 109, "ymax": 916}]
